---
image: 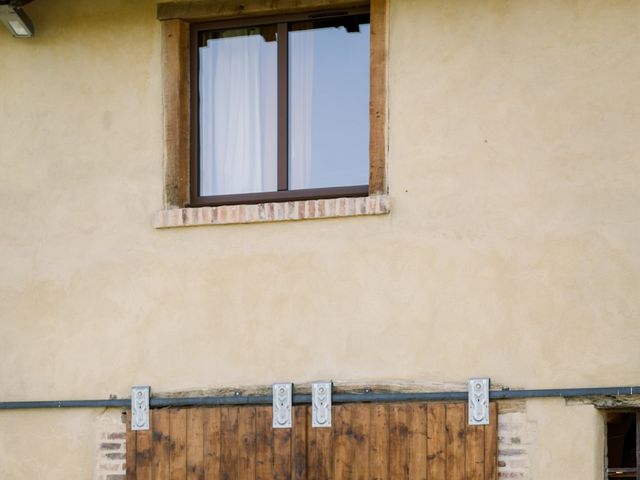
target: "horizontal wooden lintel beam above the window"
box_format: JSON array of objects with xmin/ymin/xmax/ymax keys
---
[{"xmin": 158, "ymin": 0, "xmax": 369, "ymax": 21}]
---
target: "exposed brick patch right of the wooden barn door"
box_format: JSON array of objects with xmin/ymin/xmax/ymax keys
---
[{"xmin": 498, "ymin": 401, "xmax": 535, "ymax": 480}]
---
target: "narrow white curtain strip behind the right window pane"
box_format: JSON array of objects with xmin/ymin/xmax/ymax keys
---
[{"xmin": 289, "ymin": 30, "xmax": 315, "ymax": 190}]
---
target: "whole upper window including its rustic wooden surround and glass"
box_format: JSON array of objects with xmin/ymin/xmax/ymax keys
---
[{"xmin": 158, "ymin": 0, "xmax": 388, "ymax": 214}]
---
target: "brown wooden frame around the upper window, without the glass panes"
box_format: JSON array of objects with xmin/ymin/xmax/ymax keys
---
[{"xmin": 158, "ymin": 0, "xmax": 389, "ymax": 209}]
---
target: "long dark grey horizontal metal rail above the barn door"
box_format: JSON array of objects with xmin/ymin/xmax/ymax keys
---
[{"xmin": 0, "ymin": 386, "xmax": 640, "ymax": 410}]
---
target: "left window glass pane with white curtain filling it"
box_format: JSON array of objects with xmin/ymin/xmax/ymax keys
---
[{"xmin": 199, "ymin": 26, "xmax": 278, "ymax": 196}]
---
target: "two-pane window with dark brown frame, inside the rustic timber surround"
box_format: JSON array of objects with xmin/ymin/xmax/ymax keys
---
[{"xmin": 190, "ymin": 8, "xmax": 370, "ymax": 206}]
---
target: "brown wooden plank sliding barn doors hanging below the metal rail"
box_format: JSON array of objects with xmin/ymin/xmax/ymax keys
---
[{"xmin": 127, "ymin": 403, "xmax": 497, "ymax": 480}]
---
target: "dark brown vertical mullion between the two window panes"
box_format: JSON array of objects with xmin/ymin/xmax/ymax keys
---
[{"xmin": 278, "ymin": 23, "xmax": 289, "ymax": 191}]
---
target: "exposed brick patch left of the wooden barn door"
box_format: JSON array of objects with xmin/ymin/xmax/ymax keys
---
[{"xmin": 95, "ymin": 416, "xmax": 127, "ymax": 480}]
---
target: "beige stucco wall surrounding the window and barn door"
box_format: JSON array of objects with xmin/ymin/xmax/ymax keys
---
[{"xmin": 0, "ymin": 0, "xmax": 640, "ymax": 479}]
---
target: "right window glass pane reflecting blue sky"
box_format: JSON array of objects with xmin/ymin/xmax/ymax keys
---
[{"xmin": 289, "ymin": 15, "xmax": 369, "ymax": 190}]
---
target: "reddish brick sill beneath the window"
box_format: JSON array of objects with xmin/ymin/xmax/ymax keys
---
[{"xmin": 153, "ymin": 195, "xmax": 390, "ymax": 228}]
